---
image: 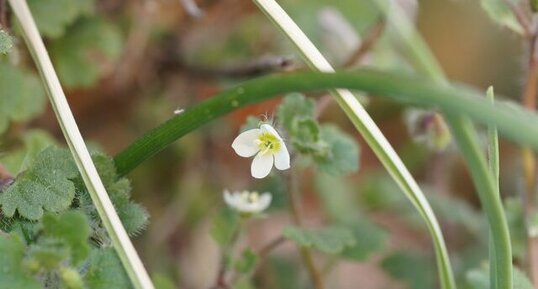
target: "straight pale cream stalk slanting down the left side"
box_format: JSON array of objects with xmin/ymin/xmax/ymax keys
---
[{"xmin": 9, "ymin": 0, "xmax": 154, "ymax": 289}]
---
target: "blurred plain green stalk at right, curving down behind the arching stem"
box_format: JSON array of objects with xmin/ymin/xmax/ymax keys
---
[{"xmin": 374, "ymin": 1, "xmax": 512, "ymax": 289}]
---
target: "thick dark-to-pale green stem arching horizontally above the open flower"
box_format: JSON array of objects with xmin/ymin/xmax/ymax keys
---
[{"xmin": 115, "ymin": 70, "xmax": 538, "ymax": 176}]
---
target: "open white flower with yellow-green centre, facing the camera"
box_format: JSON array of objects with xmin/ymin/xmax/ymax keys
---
[{"xmin": 232, "ymin": 124, "xmax": 290, "ymax": 179}]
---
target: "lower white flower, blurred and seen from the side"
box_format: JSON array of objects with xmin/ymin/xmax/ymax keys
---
[{"xmin": 224, "ymin": 190, "xmax": 272, "ymax": 214}]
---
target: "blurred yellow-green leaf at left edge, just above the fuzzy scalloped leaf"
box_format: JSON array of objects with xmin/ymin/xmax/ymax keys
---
[{"xmin": 0, "ymin": 129, "xmax": 57, "ymax": 175}]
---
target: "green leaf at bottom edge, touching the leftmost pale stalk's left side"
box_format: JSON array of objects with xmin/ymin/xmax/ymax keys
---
[{"xmin": 84, "ymin": 247, "xmax": 132, "ymax": 289}]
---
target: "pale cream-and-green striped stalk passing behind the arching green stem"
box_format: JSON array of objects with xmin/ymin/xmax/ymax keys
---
[{"xmin": 249, "ymin": 0, "xmax": 455, "ymax": 289}]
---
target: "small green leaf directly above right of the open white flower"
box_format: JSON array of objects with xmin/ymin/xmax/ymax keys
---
[{"xmin": 277, "ymin": 93, "xmax": 316, "ymax": 131}]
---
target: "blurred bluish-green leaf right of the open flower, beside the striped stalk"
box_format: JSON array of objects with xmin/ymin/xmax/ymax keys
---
[{"xmin": 314, "ymin": 125, "xmax": 359, "ymax": 175}]
